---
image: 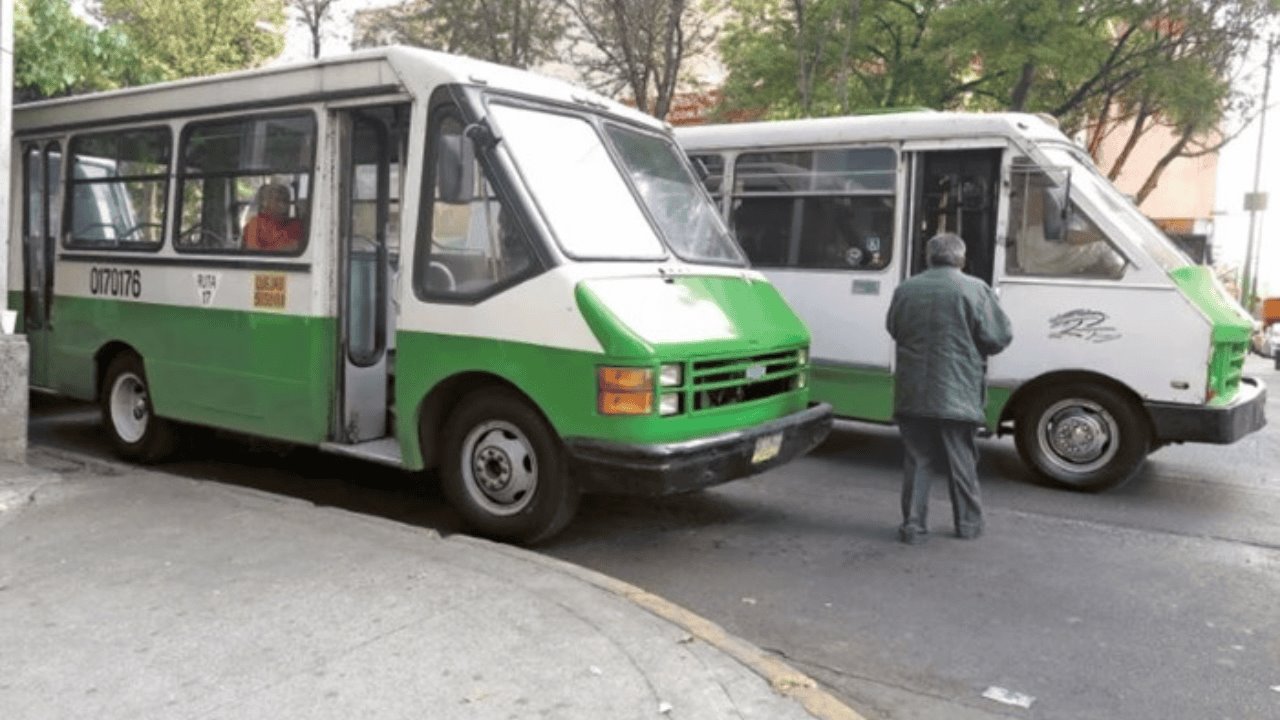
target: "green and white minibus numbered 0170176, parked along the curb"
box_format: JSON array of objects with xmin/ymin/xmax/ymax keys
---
[{"xmin": 9, "ymin": 47, "xmax": 831, "ymax": 542}]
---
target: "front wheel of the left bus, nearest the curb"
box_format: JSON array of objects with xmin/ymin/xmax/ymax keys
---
[{"xmin": 440, "ymin": 388, "xmax": 579, "ymax": 544}]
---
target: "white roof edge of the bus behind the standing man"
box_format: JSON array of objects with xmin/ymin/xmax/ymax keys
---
[{"xmin": 676, "ymin": 111, "xmax": 1066, "ymax": 150}]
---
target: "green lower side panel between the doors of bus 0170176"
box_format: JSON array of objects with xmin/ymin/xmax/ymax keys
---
[{"xmin": 50, "ymin": 297, "xmax": 337, "ymax": 445}]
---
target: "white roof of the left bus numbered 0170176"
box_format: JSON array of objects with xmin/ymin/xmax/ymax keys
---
[{"xmin": 13, "ymin": 45, "xmax": 662, "ymax": 135}]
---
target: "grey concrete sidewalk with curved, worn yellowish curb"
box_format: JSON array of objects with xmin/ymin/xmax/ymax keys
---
[{"xmin": 0, "ymin": 448, "xmax": 860, "ymax": 720}]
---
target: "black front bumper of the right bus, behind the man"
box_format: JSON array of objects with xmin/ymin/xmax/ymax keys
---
[{"xmin": 1146, "ymin": 378, "xmax": 1267, "ymax": 445}]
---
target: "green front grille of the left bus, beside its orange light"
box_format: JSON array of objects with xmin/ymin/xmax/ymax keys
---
[{"xmin": 689, "ymin": 350, "xmax": 803, "ymax": 413}]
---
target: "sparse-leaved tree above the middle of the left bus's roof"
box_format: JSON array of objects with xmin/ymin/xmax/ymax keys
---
[{"xmin": 355, "ymin": 0, "xmax": 564, "ymax": 68}]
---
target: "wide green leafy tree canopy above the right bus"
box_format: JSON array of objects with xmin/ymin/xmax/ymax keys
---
[{"xmin": 723, "ymin": 0, "xmax": 1280, "ymax": 201}]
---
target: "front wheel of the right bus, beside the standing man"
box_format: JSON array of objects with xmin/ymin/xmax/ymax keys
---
[{"xmin": 1014, "ymin": 383, "xmax": 1152, "ymax": 492}]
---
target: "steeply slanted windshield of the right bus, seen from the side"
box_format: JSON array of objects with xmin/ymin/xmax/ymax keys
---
[{"xmin": 1039, "ymin": 145, "xmax": 1192, "ymax": 272}]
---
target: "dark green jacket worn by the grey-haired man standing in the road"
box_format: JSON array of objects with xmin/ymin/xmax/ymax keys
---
[{"xmin": 884, "ymin": 266, "xmax": 1014, "ymax": 424}]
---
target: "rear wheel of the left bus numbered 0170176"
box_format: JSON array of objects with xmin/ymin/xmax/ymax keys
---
[{"xmin": 101, "ymin": 352, "xmax": 174, "ymax": 462}]
